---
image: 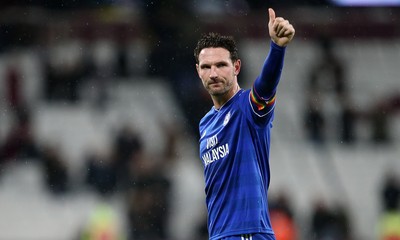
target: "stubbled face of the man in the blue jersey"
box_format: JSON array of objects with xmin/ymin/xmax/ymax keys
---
[{"xmin": 196, "ymin": 48, "xmax": 240, "ymax": 96}]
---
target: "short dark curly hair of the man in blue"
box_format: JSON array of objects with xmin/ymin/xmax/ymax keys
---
[{"xmin": 194, "ymin": 32, "xmax": 239, "ymax": 63}]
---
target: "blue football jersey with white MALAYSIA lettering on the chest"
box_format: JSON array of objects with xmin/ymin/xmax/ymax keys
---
[{"xmin": 199, "ymin": 90, "xmax": 275, "ymax": 240}]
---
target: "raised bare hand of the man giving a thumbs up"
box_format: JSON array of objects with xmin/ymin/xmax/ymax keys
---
[{"xmin": 268, "ymin": 8, "xmax": 295, "ymax": 47}]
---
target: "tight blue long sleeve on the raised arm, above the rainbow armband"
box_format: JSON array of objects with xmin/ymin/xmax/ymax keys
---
[{"xmin": 253, "ymin": 41, "xmax": 286, "ymax": 101}]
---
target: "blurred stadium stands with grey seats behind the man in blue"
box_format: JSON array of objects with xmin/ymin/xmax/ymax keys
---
[{"xmin": 0, "ymin": 0, "xmax": 400, "ymax": 240}]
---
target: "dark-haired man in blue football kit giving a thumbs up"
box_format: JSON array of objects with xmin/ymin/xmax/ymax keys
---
[{"xmin": 194, "ymin": 9, "xmax": 295, "ymax": 240}]
